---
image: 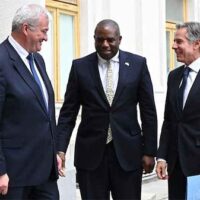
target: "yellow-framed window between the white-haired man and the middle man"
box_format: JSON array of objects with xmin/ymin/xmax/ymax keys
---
[{"xmin": 44, "ymin": 0, "xmax": 79, "ymax": 102}]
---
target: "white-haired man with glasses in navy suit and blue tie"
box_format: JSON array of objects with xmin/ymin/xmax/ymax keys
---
[{"xmin": 0, "ymin": 4, "xmax": 61, "ymax": 200}]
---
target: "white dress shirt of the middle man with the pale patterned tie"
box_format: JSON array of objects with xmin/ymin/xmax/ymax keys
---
[{"xmin": 97, "ymin": 52, "xmax": 119, "ymax": 93}]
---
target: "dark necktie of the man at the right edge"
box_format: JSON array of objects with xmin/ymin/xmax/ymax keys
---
[{"xmin": 178, "ymin": 67, "xmax": 190, "ymax": 110}]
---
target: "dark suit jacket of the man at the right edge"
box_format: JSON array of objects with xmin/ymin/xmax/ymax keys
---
[{"xmin": 157, "ymin": 66, "xmax": 200, "ymax": 176}]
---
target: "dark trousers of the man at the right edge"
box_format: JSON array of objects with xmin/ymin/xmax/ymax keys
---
[{"xmin": 168, "ymin": 159, "xmax": 187, "ymax": 200}]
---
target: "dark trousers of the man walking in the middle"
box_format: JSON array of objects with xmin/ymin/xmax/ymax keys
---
[{"xmin": 77, "ymin": 142, "xmax": 142, "ymax": 200}]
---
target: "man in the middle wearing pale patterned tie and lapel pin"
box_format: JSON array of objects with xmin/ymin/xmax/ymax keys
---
[{"xmin": 58, "ymin": 20, "xmax": 157, "ymax": 200}]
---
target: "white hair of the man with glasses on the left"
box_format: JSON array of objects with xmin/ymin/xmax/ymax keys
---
[{"xmin": 12, "ymin": 4, "xmax": 49, "ymax": 32}]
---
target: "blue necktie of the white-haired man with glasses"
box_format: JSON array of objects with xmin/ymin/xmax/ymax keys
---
[{"xmin": 27, "ymin": 53, "xmax": 48, "ymax": 110}]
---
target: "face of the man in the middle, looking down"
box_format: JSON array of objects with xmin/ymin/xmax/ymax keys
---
[{"xmin": 94, "ymin": 25, "xmax": 122, "ymax": 60}]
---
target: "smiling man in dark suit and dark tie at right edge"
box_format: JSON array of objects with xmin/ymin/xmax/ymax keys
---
[{"xmin": 156, "ymin": 22, "xmax": 200, "ymax": 200}]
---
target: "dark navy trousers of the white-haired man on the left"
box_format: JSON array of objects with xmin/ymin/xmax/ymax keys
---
[{"xmin": 0, "ymin": 181, "xmax": 59, "ymax": 200}]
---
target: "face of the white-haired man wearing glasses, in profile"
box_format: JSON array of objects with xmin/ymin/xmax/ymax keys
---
[{"xmin": 26, "ymin": 15, "xmax": 49, "ymax": 53}]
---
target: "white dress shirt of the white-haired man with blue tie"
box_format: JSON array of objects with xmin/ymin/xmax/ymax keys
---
[{"xmin": 8, "ymin": 35, "xmax": 49, "ymax": 107}]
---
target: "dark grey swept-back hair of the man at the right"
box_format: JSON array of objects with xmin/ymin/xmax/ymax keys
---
[{"xmin": 176, "ymin": 22, "xmax": 200, "ymax": 42}]
